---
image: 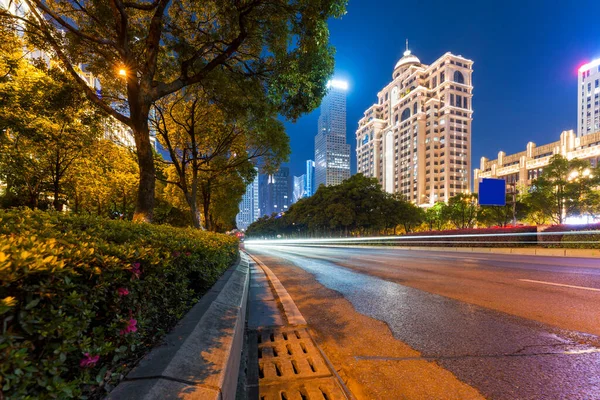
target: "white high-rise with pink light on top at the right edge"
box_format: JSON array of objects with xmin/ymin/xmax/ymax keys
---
[{"xmin": 577, "ymin": 58, "xmax": 600, "ymax": 137}]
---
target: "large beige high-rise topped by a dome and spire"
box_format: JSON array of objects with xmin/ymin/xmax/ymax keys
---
[{"xmin": 356, "ymin": 43, "xmax": 473, "ymax": 206}]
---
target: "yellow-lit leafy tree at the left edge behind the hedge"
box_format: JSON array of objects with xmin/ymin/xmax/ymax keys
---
[{"xmin": 0, "ymin": 36, "xmax": 101, "ymax": 211}]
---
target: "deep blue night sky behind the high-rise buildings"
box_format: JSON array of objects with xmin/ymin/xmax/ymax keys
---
[{"xmin": 286, "ymin": 0, "xmax": 600, "ymax": 181}]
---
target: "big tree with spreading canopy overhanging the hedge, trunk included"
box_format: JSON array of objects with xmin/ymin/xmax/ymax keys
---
[{"xmin": 0, "ymin": 0, "xmax": 346, "ymax": 221}]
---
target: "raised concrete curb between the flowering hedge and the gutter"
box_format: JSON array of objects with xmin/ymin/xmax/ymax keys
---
[{"xmin": 106, "ymin": 255, "xmax": 250, "ymax": 400}]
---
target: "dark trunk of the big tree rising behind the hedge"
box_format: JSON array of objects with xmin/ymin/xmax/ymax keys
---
[{"xmin": 130, "ymin": 108, "xmax": 156, "ymax": 222}]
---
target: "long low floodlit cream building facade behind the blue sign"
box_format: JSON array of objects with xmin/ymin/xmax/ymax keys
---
[{"xmin": 474, "ymin": 130, "xmax": 600, "ymax": 193}]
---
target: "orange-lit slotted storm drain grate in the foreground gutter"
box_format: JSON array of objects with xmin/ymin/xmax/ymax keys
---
[{"xmin": 248, "ymin": 327, "xmax": 346, "ymax": 400}]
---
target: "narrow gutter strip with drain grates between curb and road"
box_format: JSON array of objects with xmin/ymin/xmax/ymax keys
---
[{"xmin": 241, "ymin": 253, "xmax": 353, "ymax": 400}]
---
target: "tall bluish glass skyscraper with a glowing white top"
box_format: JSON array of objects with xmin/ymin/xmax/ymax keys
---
[{"xmin": 314, "ymin": 80, "xmax": 350, "ymax": 190}]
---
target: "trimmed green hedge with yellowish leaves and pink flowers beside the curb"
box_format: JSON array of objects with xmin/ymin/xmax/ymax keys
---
[{"xmin": 0, "ymin": 210, "xmax": 237, "ymax": 399}]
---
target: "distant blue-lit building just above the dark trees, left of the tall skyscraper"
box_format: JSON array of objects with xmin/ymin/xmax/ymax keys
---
[{"xmin": 259, "ymin": 167, "xmax": 292, "ymax": 216}]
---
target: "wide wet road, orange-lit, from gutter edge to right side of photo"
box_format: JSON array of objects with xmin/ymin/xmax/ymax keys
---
[{"xmin": 247, "ymin": 246, "xmax": 600, "ymax": 400}]
